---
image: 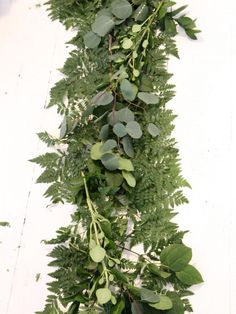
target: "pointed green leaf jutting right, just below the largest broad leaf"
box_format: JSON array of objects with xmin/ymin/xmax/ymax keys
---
[{"xmin": 176, "ymin": 265, "xmax": 203, "ymax": 286}]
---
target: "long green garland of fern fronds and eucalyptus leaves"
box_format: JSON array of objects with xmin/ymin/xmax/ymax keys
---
[{"xmin": 32, "ymin": 0, "xmax": 203, "ymax": 314}]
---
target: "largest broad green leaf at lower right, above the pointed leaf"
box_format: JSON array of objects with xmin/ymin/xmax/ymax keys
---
[{"xmin": 160, "ymin": 244, "xmax": 192, "ymax": 271}]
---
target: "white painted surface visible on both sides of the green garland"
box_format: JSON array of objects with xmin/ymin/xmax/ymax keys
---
[{"xmin": 0, "ymin": 0, "xmax": 236, "ymax": 314}]
